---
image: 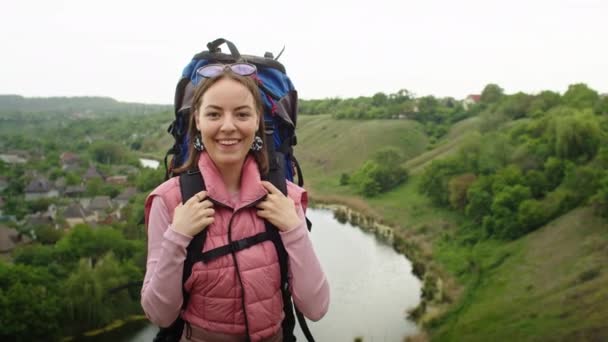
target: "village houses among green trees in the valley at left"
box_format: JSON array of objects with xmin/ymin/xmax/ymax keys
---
[{"xmin": 0, "ymin": 150, "xmax": 151, "ymax": 257}]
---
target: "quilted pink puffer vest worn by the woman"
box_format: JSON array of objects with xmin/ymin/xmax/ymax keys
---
[{"xmin": 145, "ymin": 153, "xmax": 307, "ymax": 341}]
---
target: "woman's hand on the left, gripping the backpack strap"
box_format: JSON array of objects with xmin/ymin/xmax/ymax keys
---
[{"xmin": 173, "ymin": 191, "xmax": 215, "ymax": 236}]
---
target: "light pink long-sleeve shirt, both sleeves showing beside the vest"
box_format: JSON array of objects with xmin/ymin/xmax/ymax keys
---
[{"xmin": 141, "ymin": 196, "xmax": 330, "ymax": 332}]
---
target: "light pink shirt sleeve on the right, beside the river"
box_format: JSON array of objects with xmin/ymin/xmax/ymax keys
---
[{"xmin": 280, "ymin": 205, "xmax": 329, "ymax": 321}]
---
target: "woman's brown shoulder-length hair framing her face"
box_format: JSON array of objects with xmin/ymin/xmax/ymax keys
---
[{"xmin": 173, "ymin": 69, "xmax": 268, "ymax": 176}]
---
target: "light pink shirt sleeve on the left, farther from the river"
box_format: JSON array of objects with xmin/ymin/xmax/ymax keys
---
[{"xmin": 141, "ymin": 196, "xmax": 192, "ymax": 327}]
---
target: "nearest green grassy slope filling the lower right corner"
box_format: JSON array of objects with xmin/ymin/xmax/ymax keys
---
[{"xmin": 435, "ymin": 208, "xmax": 608, "ymax": 341}]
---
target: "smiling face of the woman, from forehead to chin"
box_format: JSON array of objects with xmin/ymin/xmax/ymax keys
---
[{"xmin": 195, "ymin": 78, "xmax": 260, "ymax": 170}]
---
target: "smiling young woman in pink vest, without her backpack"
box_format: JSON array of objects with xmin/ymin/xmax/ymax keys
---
[{"xmin": 141, "ymin": 63, "xmax": 329, "ymax": 342}]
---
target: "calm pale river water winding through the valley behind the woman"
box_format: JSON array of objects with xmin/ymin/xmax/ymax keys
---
[{"xmin": 86, "ymin": 206, "xmax": 421, "ymax": 342}]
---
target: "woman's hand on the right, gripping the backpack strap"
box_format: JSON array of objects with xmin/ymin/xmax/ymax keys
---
[{"xmin": 257, "ymin": 181, "xmax": 301, "ymax": 232}]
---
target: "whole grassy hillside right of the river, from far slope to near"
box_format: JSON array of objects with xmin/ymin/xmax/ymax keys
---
[{"xmin": 297, "ymin": 116, "xmax": 608, "ymax": 341}]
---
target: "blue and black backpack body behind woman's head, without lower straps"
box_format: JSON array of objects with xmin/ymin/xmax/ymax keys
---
[{"xmin": 164, "ymin": 38, "xmax": 304, "ymax": 192}]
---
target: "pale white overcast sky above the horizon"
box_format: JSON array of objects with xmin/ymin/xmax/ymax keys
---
[{"xmin": 0, "ymin": 0, "xmax": 608, "ymax": 104}]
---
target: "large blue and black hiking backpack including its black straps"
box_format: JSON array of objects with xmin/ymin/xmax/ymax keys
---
[{"xmin": 154, "ymin": 38, "xmax": 314, "ymax": 342}]
